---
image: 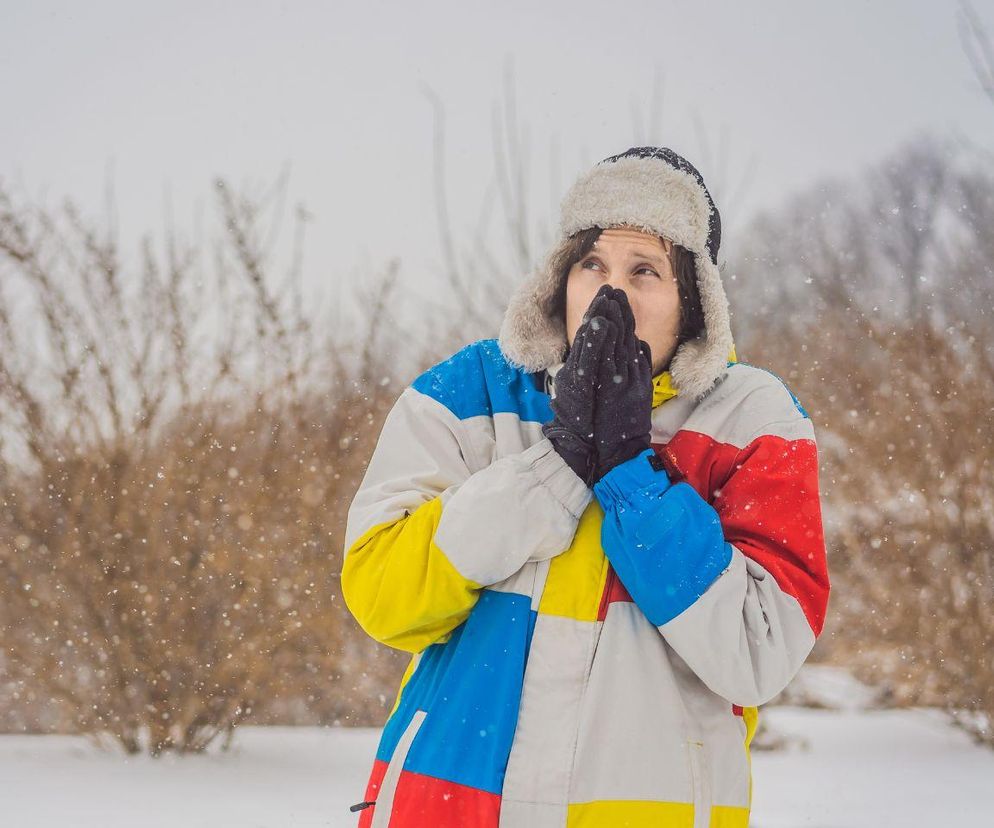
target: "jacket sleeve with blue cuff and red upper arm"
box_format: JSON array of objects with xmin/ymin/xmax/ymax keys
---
[{"xmin": 594, "ymin": 416, "xmax": 829, "ymax": 707}]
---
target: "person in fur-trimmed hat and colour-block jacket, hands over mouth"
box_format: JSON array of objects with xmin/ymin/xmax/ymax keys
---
[{"xmin": 342, "ymin": 147, "xmax": 829, "ymax": 828}]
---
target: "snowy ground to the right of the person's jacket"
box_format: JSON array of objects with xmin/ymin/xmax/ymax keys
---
[{"xmin": 750, "ymin": 707, "xmax": 994, "ymax": 828}]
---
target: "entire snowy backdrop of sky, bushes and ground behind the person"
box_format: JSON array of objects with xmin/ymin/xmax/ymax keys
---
[{"xmin": 0, "ymin": 0, "xmax": 994, "ymax": 828}]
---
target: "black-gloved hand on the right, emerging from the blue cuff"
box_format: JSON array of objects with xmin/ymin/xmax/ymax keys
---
[{"xmin": 588, "ymin": 285, "xmax": 652, "ymax": 482}]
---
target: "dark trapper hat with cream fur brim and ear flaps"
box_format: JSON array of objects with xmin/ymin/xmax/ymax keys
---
[{"xmin": 498, "ymin": 147, "xmax": 733, "ymax": 398}]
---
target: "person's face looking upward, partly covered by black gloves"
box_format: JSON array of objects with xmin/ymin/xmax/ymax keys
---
[{"xmin": 566, "ymin": 227, "xmax": 680, "ymax": 376}]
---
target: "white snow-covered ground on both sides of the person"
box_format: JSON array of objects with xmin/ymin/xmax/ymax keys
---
[{"xmin": 0, "ymin": 706, "xmax": 994, "ymax": 828}]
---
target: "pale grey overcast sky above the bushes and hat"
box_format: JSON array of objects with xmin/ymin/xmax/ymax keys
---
[{"xmin": 0, "ymin": 0, "xmax": 994, "ymax": 320}]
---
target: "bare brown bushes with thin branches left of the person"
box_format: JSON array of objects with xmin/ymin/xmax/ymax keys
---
[{"xmin": 0, "ymin": 171, "xmax": 430, "ymax": 754}]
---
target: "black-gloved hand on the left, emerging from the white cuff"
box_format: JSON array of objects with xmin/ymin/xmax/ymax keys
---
[{"xmin": 542, "ymin": 300, "xmax": 608, "ymax": 486}]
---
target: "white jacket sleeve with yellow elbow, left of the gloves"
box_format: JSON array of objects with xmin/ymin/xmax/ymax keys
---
[{"xmin": 341, "ymin": 385, "xmax": 593, "ymax": 653}]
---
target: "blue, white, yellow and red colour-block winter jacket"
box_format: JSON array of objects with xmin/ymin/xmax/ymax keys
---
[{"xmin": 342, "ymin": 339, "xmax": 829, "ymax": 828}]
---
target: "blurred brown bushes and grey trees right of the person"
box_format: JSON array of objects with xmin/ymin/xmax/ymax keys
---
[{"xmin": 732, "ymin": 136, "xmax": 994, "ymax": 744}]
